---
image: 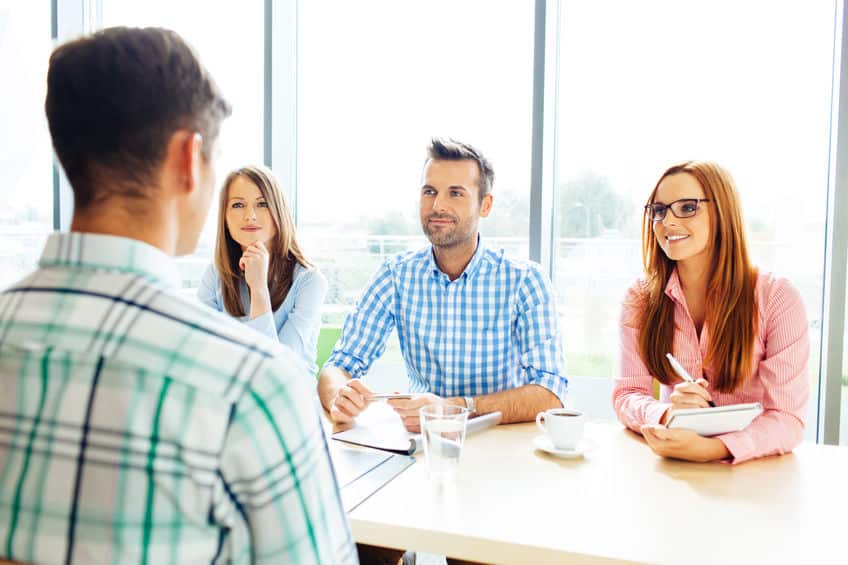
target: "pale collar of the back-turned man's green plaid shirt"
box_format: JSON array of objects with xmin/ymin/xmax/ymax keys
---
[{"xmin": 38, "ymin": 232, "xmax": 181, "ymax": 288}]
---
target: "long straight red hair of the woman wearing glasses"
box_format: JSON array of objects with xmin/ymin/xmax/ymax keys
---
[{"xmin": 636, "ymin": 161, "xmax": 758, "ymax": 392}]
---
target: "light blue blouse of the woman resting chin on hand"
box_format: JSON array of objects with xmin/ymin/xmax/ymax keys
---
[{"xmin": 197, "ymin": 264, "xmax": 327, "ymax": 375}]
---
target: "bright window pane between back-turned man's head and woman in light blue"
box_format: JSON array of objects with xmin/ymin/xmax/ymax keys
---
[{"xmin": 102, "ymin": 0, "xmax": 264, "ymax": 287}]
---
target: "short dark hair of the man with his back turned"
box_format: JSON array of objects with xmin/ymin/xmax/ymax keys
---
[{"xmin": 44, "ymin": 27, "xmax": 231, "ymax": 208}]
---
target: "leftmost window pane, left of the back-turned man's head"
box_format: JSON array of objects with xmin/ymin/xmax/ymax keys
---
[{"xmin": 0, "ymin": 2, "xmax": 53, "ymax": 288}]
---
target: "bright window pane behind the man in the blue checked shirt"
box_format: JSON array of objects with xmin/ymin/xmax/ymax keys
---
[{"xmin": 297, "ymin": 0, "xmax": 533, "ymax": 384}]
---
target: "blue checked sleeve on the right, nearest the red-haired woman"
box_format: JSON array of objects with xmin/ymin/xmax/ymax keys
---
[{"xmin": 516, "ymin": 265, "xmax": 568, "ymax": 405}]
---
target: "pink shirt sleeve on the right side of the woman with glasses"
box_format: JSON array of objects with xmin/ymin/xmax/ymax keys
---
[{"xmin": 718, "ymin": 279, "xmax": 810, "ymax": 463}]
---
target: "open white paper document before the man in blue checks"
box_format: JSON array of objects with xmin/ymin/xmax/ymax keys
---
[{"xmin": 332, "ymin": 402, "xmax": 501, "ymax": 455}]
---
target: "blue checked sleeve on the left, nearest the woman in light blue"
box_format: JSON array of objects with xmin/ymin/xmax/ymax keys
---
[{"xmin": 324, "ymin": 263, "xmax": 395, "ymax": 379}]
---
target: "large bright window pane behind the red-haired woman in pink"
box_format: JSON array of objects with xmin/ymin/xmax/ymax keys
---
[{"xmin": 555, "ymin": 0, "xmax": 835, "ymax": 428}]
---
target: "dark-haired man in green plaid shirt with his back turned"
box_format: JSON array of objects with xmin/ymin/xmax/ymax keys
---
[{"xmin": 0, "ymin": 28, "xmax": 357, "ymax": 565}]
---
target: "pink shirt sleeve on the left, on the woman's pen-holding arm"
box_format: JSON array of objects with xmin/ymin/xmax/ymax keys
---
[{"xmin": 612, "ymin": 282, "xmax": 671, "ymax": 432}]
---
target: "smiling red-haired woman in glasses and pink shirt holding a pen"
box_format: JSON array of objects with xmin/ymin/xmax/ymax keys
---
[{"xmin": 613, "ymin": 161, "xmax": 810, "ymax": 463}]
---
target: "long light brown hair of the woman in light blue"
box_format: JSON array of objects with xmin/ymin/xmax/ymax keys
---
[{"xmin": 215, "ymin": 165, "xmax": 312, "ymax": 317}]
